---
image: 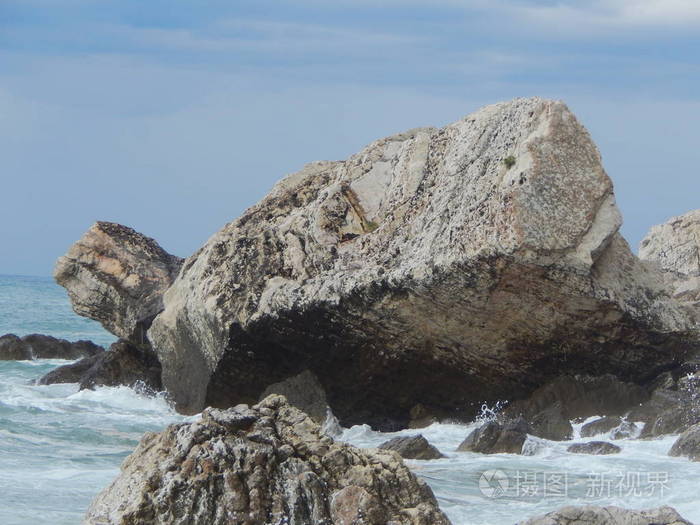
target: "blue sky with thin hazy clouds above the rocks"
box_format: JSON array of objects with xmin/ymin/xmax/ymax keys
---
[{"xmin": 0, "ymin": 0, "xmax": 700, "ymax": 275}]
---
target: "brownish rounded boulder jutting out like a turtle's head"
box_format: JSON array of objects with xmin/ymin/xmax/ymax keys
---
[{"xmin": 54, "ymin": 222, "xmax": 182, "ymax": 345}]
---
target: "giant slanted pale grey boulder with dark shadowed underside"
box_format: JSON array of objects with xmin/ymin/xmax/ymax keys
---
[{"xmin": 144, "ymin": 98, "xmax": 698, "ymax": 429}]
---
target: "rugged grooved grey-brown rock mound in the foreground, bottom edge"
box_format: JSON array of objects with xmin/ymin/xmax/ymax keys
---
[{"xmin": 85, "ymin": 396, "xmax": 449, "ymax": 525}]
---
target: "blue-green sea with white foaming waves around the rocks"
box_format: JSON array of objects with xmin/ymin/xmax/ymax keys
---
[{"xmin": 0, "ymin": 276, "xmax": 700, "ymax": 525}]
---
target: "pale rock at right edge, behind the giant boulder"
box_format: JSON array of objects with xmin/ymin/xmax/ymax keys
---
[{"xmin": 639, "ymin": 210, "xmax": 700, "ymax": 313}]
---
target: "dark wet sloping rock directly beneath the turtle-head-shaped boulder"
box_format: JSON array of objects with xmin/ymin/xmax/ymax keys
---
[{"xmin": 39, "ymin": 340, "xmax": 163, "ymax": 392}]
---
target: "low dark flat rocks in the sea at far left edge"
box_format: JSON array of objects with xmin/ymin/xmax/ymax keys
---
[{"xmin": 0, "ymin": 334, "xmax": 104, "ymax": 361}]
